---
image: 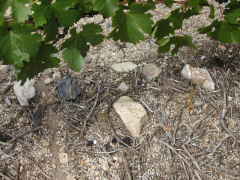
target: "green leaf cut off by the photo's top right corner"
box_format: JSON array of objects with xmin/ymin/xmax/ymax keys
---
[{"xmin": 224, "ymin": 0, "xmax": 240, "ymax": 24}]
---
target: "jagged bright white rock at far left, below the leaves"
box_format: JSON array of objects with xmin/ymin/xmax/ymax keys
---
[{"xmin": 13, "ymin": 79, "xmax": 35, "ymax": 106}]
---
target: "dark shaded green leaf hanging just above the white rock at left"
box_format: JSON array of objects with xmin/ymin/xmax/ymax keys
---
[{"xmin": 17, "ymin": 44, "xmax": 60, "ymax": 85}]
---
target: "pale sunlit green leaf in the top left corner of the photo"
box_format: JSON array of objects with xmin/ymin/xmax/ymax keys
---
[{"xmin": 0, "ymin": 0, "xmax": 32, "ymax": 25}]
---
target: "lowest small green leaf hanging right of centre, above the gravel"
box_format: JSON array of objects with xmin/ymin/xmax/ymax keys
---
[{"xmin": 157, "ymin": 35, "xmax": 196, "ymax": 56}]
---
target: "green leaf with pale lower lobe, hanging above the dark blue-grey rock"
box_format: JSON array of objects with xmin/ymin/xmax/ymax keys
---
[{"xmin": 61, "ymin": 23, "xmax": 103, "ymax": 71}]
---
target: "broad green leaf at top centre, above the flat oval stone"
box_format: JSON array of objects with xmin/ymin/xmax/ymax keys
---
[{"xmin": 109, "ymin": 4, "xmax": 153, "ymax": 44}]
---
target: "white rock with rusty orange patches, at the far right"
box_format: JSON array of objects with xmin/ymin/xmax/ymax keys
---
[{"xmin": 182, "ymin": 64, "xmax": 215, "ymax": 91}]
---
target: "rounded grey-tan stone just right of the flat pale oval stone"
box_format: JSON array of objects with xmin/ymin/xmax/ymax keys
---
[{"xmin": 142, "ymin": 64, "xmax": 161, "ymax": 80}]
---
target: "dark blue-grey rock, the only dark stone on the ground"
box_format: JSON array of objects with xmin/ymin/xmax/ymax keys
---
[{"xmin": 57, "ymin": 78, "xmax": 81, "ymax": 101}]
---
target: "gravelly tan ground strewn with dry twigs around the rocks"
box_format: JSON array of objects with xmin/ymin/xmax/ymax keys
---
[{"xmin": 0, "ymin": 5, "xmax": 240, "ymax": 180}]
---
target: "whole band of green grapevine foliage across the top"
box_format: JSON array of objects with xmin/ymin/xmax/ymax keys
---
[{"xmin": 0, "ymin": 0, "xmax": 240, "ymax": 84}]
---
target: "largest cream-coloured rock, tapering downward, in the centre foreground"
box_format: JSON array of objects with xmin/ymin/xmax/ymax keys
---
[{"xmin": 113, "ymin": 96, "xmax": 148, "ymax": 137}]
